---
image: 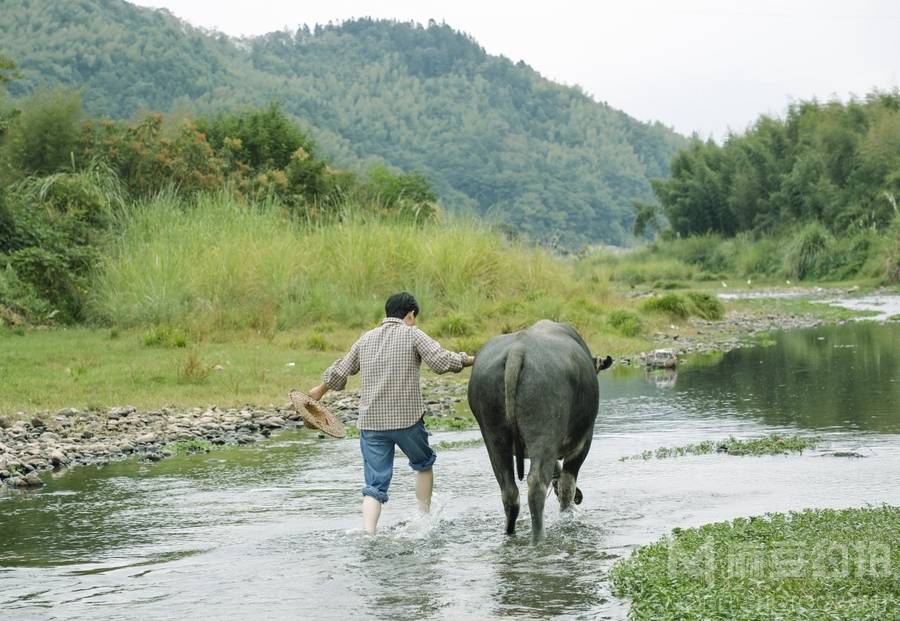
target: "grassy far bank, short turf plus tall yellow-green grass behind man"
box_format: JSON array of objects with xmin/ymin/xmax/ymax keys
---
[{"xmin": 0, "ymin": 194, "xmax": 892, "ymax": 414}]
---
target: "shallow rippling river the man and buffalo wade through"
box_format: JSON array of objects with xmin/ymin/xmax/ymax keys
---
[{"xmin": 0, "ymin": 323, "xmax": 900, "ymax": 621}]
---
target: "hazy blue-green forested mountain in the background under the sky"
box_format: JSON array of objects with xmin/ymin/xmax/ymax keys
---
[{"xmin": 0, "ymin": 0, "xmax": 685, "ymax": 249}]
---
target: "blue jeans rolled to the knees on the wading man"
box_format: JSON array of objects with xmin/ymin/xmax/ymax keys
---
[{"xmin": 359, "ymin": 418, "xmax": 437, "ymax": 503}]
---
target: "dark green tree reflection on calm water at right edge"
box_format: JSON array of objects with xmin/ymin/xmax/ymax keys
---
[{"xmin": 678, "ymin": 323, "xmax": 900, "ymax": 433}]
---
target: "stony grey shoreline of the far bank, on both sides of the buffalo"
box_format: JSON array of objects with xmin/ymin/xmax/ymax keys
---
[{"xmin": 0, "ymin": 290, "xmax": 896, "ymax": 487}]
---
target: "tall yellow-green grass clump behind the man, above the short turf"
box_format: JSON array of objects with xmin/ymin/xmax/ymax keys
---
[{"xmin": 92, "ymin": 194, "xmax": 583, "ymax": 331}]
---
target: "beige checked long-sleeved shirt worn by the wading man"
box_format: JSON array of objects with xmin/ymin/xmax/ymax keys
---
[{"xmin": 322, "ymin": 317, "xmax": 466, "ymax": 431}]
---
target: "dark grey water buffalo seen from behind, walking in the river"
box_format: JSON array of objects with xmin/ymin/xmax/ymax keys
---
[{"xmin": 469, "ymin": 320, "xmax": 612, "ymax": 541}]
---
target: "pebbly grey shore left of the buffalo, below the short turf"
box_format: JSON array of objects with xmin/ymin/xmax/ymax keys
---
[{"xmin": 0, "ymin": 381, "xmax": 466, "ymax": 488}]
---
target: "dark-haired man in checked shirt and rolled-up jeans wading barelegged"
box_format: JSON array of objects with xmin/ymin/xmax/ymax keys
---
[{"xmin": 309, "ymin": 292, "xmax": 475, "ymax": 535}]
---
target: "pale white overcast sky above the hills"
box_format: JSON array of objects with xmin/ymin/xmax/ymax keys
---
[{"xmin": 133, "ymin": 0, "xmax": 900, "ymax": 139}]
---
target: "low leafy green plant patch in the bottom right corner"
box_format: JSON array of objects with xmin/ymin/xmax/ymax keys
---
[{"xmin": 610, "ymin": 506, "xmax": 900, "ymax": 621}]
